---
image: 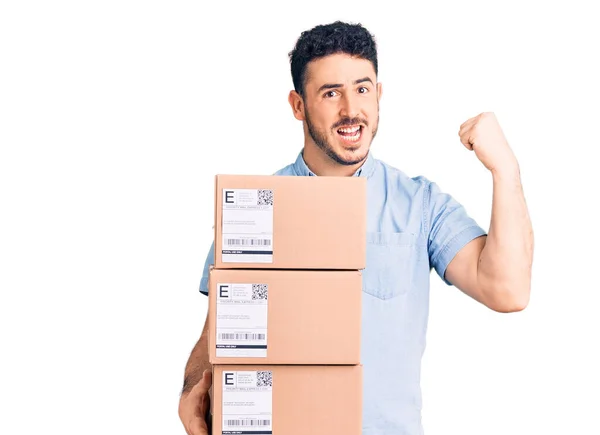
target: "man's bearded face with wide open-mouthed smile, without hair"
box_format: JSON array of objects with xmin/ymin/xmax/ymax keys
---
[{"xmin": 304, "ymin": 54, "xmax": 381, "ymax": 165}]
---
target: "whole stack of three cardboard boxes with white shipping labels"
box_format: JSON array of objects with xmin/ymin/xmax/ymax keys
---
[{"xmin": 209, "ymin": 175, "xmax": 366, "ymax": 435}]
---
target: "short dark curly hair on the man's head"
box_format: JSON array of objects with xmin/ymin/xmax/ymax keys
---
[{"xmin": 289, "ymin": 21, "xmax": 377, "ymax": 97}]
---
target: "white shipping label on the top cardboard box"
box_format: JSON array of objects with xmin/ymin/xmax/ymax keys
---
[{"xmin": 221, "ymin": 189, "xmax": 273, "ymax": 263}]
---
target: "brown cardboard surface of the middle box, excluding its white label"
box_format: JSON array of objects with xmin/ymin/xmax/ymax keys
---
[{"xmin": 208, "ymin": 268, "xmax": 362, "ymax": 364}]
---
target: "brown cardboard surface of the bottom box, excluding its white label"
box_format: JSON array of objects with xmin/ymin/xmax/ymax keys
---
[{"xmin": 212, "ymin": 365, "xmax": 363, "ymax": 435}]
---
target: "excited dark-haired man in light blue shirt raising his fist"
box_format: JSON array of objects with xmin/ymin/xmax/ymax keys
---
[{"xmin": 179, "ymin": 22, "xmax": 533, "ymax": 435}]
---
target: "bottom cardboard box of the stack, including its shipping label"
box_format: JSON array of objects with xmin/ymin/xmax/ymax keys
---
[{"xmin": 211, "ymin": 365, "xmax": 363, "ymax": 435}]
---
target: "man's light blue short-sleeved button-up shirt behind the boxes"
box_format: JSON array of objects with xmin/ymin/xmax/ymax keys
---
[{"xmin": 200, "ymin": 151, "xmax": 486, "ymax": 435}]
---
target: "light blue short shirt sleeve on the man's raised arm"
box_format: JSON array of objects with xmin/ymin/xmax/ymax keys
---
[{"xmin": 425, "ymin": 182, "xmax": 486, "ymax": 285}]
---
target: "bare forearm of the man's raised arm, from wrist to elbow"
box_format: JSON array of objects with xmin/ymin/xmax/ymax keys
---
[{"xmin": 477, "ymin": 163, "xmax": 533, "ymax": 311}]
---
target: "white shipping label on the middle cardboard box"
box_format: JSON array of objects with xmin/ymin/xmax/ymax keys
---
[{"xmin": 216, "ymin": 283, "xmax": 269, "ymax": 358}]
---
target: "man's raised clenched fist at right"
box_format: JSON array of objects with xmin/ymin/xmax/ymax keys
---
[{"xmin": 458, "ymin": 112, "xmax": 518, "ymax": 172}]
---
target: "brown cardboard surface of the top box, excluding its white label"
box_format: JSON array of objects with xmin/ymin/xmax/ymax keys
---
[{"xmin": 214, "ymin": 175, "xmax": 366, "ymax": 270}]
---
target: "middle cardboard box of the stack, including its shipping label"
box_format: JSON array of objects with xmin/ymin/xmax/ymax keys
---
[{"xmin": 208, "ymin": 267, "xmax": 362, "ymax": 364}]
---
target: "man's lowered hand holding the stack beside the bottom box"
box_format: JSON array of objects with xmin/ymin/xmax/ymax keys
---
[{"xmin": 179, "ymin": 370, "xmax": 212, "ymax": 435}]
